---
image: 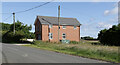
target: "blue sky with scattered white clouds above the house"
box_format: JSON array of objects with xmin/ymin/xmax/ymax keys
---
[{"xmin": 2, "ymin": 2, "xmax": 118, "ymax": 37}]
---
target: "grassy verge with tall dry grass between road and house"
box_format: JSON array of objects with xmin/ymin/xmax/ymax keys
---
[{"xmin": 23, "ymin": 41, "xmax": 120, "ymax": 63}]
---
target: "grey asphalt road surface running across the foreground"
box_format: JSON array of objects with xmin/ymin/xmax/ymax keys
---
[{"xmin": 2, "ymin": 44, "xmax": 106, "ymax": 63}]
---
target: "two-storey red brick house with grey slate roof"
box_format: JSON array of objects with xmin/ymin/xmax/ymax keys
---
[{"xmin": 34, "ymin": 16, "xmax": 81, "ymax": 42}]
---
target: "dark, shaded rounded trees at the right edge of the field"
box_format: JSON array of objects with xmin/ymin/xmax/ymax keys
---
[{"xmin": 98, "ymin": 24, "xmax": 120, "ymax": 46}]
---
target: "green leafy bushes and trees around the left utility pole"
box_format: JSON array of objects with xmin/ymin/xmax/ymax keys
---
[{"xmin": 1, "ymin": 21, "xmax": 35, "ymax": 43}]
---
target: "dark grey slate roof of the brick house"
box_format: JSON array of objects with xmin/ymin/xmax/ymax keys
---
[{"xmin": 37, "ymin": 16, "xmax": 81, "ymax": 26}]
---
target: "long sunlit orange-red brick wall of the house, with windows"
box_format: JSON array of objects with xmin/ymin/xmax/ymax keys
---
[{"xmin": 42, "ymin": 25, "xmax": 80, "ymax": 42}]
